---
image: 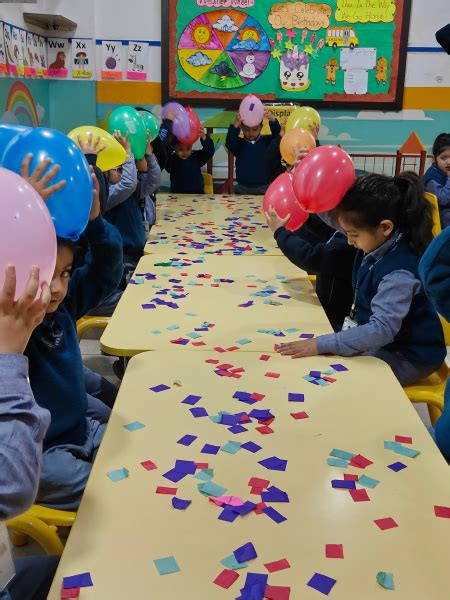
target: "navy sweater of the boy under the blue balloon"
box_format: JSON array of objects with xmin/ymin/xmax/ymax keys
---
[{"xmin": 25, "ymin": 217, "xmax": 123, "ymax": 448}]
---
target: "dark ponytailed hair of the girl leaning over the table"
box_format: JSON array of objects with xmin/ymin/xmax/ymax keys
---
[{"xmin": 338, "ymin": 172, "xmax": 433, "ymax": 254}]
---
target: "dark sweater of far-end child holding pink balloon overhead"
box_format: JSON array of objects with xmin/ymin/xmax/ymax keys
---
[{"xmin": 226, "ymin": 119, "xmax": 281, "ymax": 187}]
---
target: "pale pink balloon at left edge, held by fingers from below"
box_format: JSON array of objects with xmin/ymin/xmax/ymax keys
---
[{"xmin": 0, "ymin": 167, "xmax": 56, "ymax": 299}]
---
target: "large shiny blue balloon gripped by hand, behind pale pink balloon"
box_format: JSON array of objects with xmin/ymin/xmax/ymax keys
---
[{"xmin": 1, "ymin": 127, "xmax": 93, "ymax": 241}]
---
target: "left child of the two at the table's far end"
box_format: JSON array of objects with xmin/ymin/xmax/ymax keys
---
[{"xmin": 166, "ymin": 127, "xmax": 214, "ymax": 194}]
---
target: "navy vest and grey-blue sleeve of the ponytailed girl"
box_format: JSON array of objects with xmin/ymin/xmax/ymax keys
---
[{"xmin": 317, "ymin": 234, "xmax": 446, "ymax": 366}]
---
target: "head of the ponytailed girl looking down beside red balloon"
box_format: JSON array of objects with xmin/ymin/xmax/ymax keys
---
[{"xmin": 338, "ymin": 173, "xmax": 433, "ymax": 254}]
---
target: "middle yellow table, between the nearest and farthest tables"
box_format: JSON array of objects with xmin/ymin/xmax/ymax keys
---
[{"xmin": 100, "ymin": 254, "xmax": 332, "ymax": 356}]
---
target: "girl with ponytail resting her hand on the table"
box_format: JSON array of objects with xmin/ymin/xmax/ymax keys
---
[{"xmin": 279, "ymin": 173, "xmax": 446, "ymax": 386}]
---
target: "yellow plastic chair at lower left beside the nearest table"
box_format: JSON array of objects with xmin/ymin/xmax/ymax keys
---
[{"xmin": 6, "ymin": 504, "xmax": 76, "ymax": 555}]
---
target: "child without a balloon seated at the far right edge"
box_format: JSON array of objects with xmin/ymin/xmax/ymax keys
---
[{"xmin": 423, "ymin": 133, "xmax": 450, "ymax": 229}]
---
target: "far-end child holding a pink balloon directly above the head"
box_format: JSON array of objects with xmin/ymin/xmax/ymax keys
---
[{"xmin": 226, "ymin": 111, "xmax": 281, "ymax": 194}]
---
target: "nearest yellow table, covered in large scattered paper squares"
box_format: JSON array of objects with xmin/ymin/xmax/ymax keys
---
[{"xmin": 48, "ymin": 351, "xmax": 450, "ymax": 600}]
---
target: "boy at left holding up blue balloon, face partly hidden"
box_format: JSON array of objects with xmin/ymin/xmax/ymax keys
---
[{"xmin": 25, "ymin": 171, "xmax": 123, "ymax": 510}]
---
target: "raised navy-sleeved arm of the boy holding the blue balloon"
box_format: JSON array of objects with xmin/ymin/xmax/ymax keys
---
[{"xmin": 66, "ymin": 177, "xmax": 123, "ymax": 319}]
